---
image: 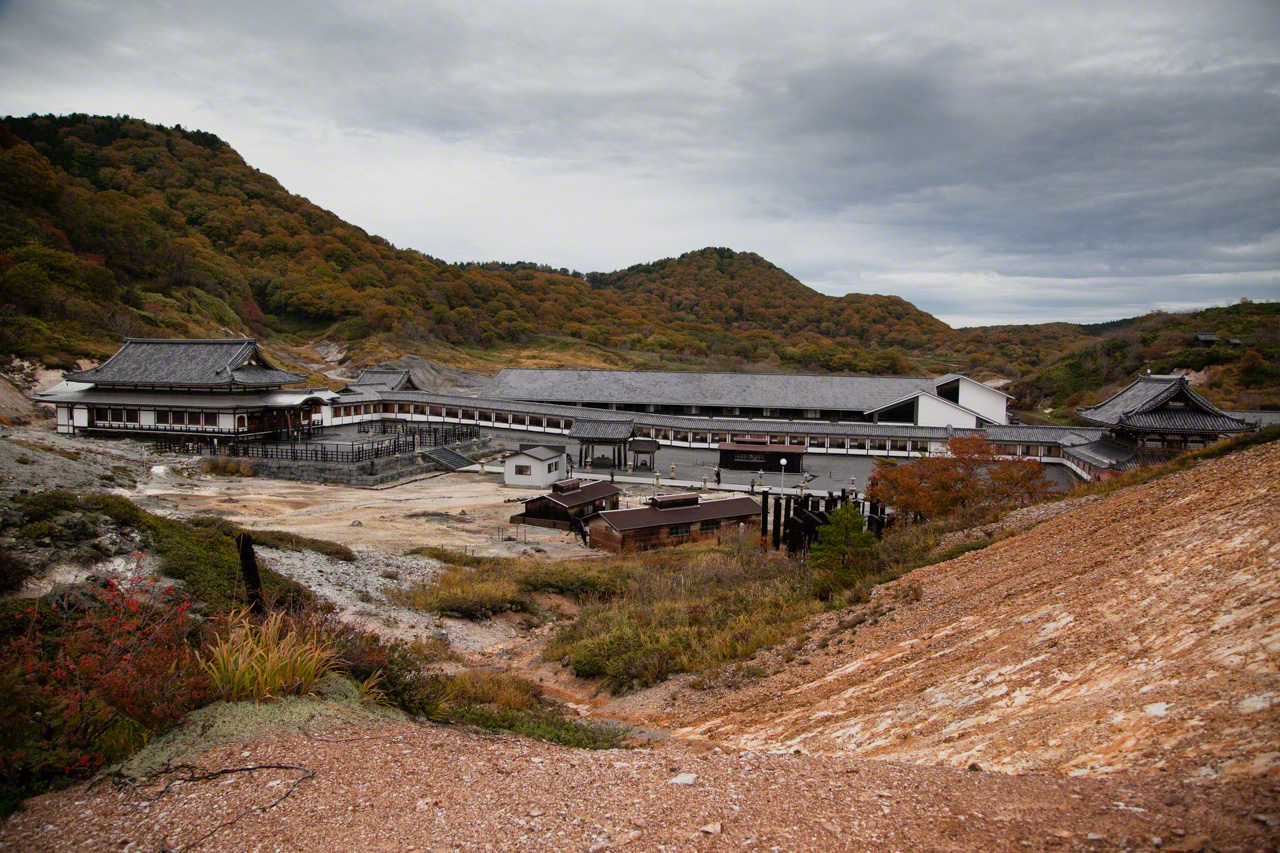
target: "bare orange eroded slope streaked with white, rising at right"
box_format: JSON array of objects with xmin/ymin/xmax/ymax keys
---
[{"xmin": 681, "ymin": 443, "xmax": 1280, "ymax": 779}]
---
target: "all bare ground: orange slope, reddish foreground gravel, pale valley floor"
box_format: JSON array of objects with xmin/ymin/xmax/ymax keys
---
[{"xmin": 0, "ymin": 422, "xmax": 1280, "ymax": 852}]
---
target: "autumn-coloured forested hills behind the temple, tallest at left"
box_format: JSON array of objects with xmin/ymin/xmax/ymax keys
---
[{"xmin": 0, "ymin": 115, "xmax": 956, "ymax": 373}]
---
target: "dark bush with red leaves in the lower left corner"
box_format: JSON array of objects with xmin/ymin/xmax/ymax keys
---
[{"xmin": 0, "ymin": 555, "xmax": 211, "ymax": 813}]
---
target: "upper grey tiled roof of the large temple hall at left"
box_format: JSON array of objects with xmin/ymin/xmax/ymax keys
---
[{"xmin": 63, "ymin": 338, "xmax": 306, "ymax": 387}]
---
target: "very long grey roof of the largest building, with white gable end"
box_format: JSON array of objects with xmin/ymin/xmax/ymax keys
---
[{"xmin": 480, "ymin": 368, "xmax": 936, "ymax": 411}]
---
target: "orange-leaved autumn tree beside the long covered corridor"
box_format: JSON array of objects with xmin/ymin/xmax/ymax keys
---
[{"xmin": 867, "ymin": 435, "xmax": 1048, "ymax": 520}]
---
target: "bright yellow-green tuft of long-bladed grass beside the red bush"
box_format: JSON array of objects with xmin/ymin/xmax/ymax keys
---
[{"xmin": 200, "ymin": 610, "xmax": 337, "ymax": 702}]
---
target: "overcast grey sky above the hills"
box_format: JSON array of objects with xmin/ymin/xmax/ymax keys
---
[{"xmin": 0, "ymin": 0, "xmax": 1280, "ymax": 325}]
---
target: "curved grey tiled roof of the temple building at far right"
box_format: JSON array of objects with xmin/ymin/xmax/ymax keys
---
[{"xmin": 1075, "ymin": 377, "xmax": 1252, "ymax": 433}]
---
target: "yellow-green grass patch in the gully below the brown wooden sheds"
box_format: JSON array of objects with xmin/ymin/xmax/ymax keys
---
[{"xmin": 390, "ymin": 542, "xmax": 819, "ymax": 692}]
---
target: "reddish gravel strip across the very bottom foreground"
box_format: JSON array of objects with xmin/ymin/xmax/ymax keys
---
[{"xmin": 0, "ymin": 724, "xmax": 1280, "ymax": 853}]
